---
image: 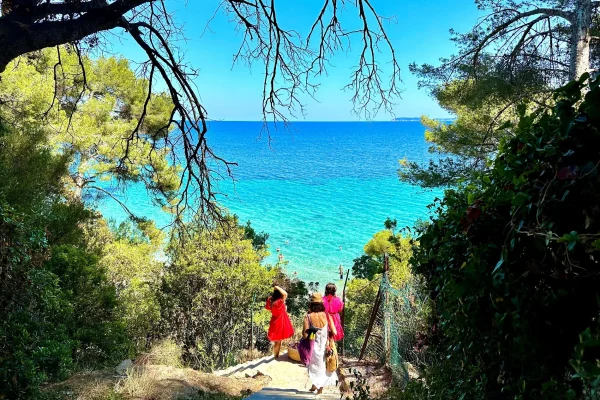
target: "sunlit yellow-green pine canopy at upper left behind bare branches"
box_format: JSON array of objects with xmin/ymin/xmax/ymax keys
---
[{"xmin": 0, "ymin": 46, "xmax": 179, "ymax": 211}]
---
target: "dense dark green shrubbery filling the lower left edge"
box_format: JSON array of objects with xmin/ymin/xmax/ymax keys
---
[{"xmin": 0, "ymin": 120, "xmax": 124, "ymax": 398}]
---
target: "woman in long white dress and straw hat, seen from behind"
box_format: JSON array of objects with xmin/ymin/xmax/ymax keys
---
[{"xmin": 303, "ymin": 293, "xmax": 338, "ymax": 394}]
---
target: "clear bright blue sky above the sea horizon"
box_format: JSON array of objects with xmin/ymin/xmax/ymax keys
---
[{"xmin": 114, "ymin": 0, "xmax": 480, "ymax": 121}]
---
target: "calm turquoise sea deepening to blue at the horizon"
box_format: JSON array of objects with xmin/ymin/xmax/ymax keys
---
[{"xmin": 99, "ymin": 121, "xmax": 442, "ymax": 283}]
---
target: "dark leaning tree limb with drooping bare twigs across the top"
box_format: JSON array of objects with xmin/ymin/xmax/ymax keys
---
[{"xmin": 0, "ymin": 0, "xmax": 400, "ymax": 223}]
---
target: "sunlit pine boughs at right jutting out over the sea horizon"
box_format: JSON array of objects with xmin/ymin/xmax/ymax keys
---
[{"xmin": 398, "ymin": 59, "xmax": 548, "ymax": 188}]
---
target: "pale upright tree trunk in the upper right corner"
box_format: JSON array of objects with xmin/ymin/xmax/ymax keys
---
[{"xmin": 569, "ymin": 0, "xmax": 592, "ymax": 80}]
